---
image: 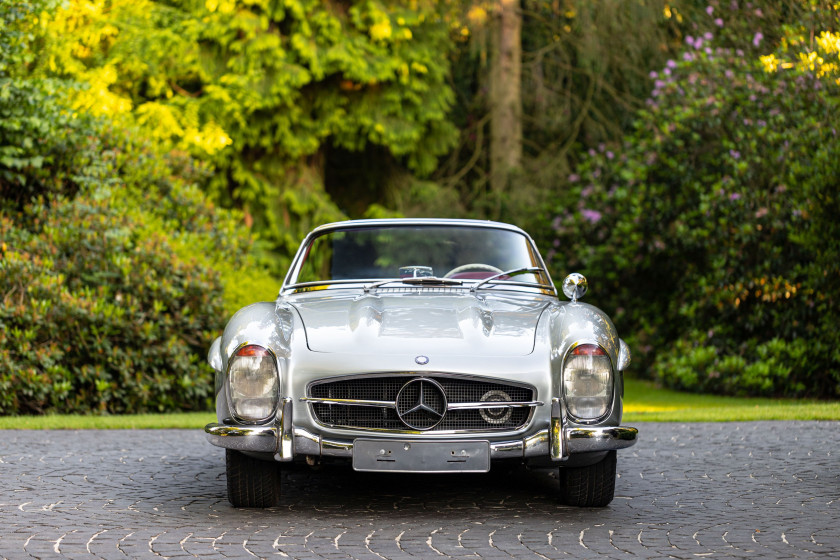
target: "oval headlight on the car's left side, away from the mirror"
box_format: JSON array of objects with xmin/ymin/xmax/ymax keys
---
[{"xmin": 228, "ymin": 344, "xmax": 279, "ymax": 422}]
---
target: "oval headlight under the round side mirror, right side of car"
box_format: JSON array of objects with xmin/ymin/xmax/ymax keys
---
[{"xmin": 563, "ymin": 344, "xmax": 613, "ymax": 420}]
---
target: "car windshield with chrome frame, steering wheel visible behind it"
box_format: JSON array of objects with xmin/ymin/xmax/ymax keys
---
[{"xmin": 291, "ymin": 225, "xmax": 550, "ymax": 285}]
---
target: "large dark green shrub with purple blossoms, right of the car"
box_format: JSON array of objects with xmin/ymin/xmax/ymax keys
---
[{"xmin": 553, "ymin": 2, "xmax": 840, "ymax": 397}]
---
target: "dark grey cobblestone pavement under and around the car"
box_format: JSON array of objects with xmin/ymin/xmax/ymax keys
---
[{"xmin": 0, "ymin": 422, "xmax": 840, "ymax": 560}]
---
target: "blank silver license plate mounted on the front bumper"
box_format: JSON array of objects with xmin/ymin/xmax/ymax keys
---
[{"xmin": 353, "ymin": 439, "xmax": 490, "ymax": 473}]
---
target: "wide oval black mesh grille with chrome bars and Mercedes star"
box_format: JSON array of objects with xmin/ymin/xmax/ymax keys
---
[{"xmin": 306, "ymin": 375, "xmax": 541, "ymax": 432}]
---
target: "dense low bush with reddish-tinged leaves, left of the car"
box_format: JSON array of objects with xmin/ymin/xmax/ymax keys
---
[{"xmin": 0, "ymin": 190, "xmax": 221, "ymax": 414}]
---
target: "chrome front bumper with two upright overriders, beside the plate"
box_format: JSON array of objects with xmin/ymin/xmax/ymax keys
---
[{"xmin": 204, "ymin": 397, "xmax": 638, "ymax": 461}]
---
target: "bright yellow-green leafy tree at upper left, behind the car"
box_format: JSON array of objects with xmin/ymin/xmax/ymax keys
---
[{"xmin": 40, "ymin": 0, "xmax": 456, "ymax": 273}]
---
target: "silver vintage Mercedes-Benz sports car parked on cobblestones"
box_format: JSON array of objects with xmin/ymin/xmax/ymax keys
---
[{"xmin": 205, "ymin": 220, "xmax": 637, "ymax": 507}]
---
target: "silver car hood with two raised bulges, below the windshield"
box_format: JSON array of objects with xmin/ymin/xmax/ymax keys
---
[{"xmin": 289, "ymin": 292, "xmax": 551, "ymax": 356}]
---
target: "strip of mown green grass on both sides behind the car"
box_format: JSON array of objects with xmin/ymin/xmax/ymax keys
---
[{"xmin": 0, "ymin": 379, "xmax": 840, "ymax": 430}]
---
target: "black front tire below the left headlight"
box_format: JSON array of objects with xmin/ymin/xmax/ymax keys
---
[{"xmin": 225, "ymin": 449, "xmax": 280, "ymax": 508}]
